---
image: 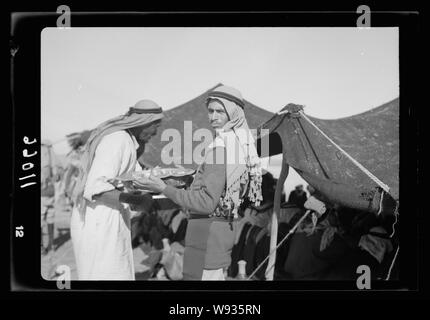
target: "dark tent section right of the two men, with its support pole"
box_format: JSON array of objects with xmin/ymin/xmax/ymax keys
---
[{"xmin": 257, "ymin": 99, "xmax": 399, "ymax": 278}]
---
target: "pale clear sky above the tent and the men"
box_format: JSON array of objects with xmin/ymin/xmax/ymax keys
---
[{"xmin": 41, "ymin": 28, "xmax": 399, "ymax": 153}]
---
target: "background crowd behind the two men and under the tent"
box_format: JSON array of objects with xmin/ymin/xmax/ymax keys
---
[{"xmin": 41, "ymin": 148, "xmax": 398, "ymax": 280}]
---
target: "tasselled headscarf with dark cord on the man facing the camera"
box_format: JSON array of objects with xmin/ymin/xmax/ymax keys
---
[{"xmin": 206, "ymin": 86, "xmax": 262, "ymax": 213}]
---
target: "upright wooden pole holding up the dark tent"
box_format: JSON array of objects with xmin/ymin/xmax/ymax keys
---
[{"xmin": 266, "ymin": 159, "xmax": 290, "ymax": 281}]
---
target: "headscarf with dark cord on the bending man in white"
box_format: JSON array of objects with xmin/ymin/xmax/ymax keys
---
[{"xmin": 73, "ymin": 100, "xmax": 163, "ymax": 203}]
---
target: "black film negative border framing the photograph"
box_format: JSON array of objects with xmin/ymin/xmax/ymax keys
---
[{"xmin": 10, "ymin": 6, "xmax": 422, "ymax": 294}]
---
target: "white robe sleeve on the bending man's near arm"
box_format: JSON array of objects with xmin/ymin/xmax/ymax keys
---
[{"xmin": 84, "ymin": 132, "xmax": 131, "ymax": 201}]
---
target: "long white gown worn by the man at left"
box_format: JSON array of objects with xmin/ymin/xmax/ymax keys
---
[{"xmin": 71, "ymin": 131, "xmax": 139, "ymax": 280}]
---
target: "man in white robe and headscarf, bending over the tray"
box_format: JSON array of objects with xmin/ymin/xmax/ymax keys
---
[{"xmin": 71, "ymin": 100, "xmax": 162, "ymax": 280}]
